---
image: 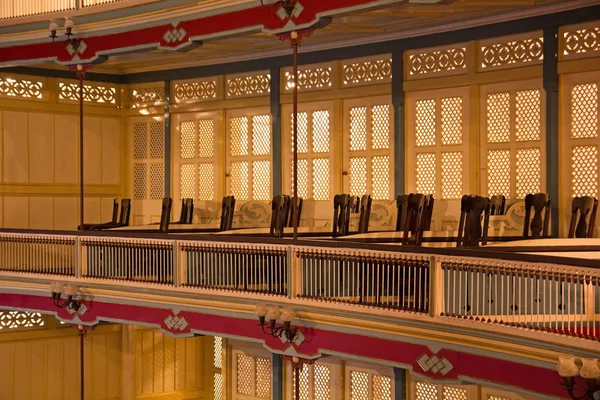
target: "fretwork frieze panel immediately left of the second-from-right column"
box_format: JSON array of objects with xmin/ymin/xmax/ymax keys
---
[{"xmin": 342, "ymin": 58, "xmax": 392, "ymax": 86}]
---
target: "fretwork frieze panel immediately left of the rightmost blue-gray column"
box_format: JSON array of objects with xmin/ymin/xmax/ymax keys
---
[{"xmin": 479, "ymin": 32, "xmax": 544, "ymax": 70}]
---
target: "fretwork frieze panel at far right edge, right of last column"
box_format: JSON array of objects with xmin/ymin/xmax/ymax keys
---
[{"xmin": 559, "ymin": 21, "xmax": 600, "ymax": 59}]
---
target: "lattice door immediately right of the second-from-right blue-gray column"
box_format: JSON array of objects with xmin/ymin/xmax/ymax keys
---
[{"xmin": 406, "ymin": 88, "xmax": 471, "ymax": 230}]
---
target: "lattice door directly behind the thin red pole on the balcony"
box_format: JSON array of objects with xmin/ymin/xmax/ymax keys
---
[{"xmin": 283, "ymin": 103, "xmax": 335, "ymax": 226}]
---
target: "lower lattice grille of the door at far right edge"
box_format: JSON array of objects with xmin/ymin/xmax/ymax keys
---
[{"xmin": 571, "ymin": 146, "xmax": 598, "ymax": 197}]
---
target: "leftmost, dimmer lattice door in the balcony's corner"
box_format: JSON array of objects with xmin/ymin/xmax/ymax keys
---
[{"xmin": 130, "ymin": 117, "xmax": 165, "ymax": 225}]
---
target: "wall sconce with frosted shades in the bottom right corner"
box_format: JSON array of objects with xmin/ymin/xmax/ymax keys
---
[{"xmin": 557, "ymin": 356, "xmax": 600, "ymax": 400}]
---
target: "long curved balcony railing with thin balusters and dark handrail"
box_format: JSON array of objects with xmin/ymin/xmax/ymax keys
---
[{"xmin": 0, "ymin": 232, "xmax": 600, "ymax": 341}]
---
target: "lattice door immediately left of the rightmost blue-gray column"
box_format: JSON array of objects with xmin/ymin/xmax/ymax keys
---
[{"xmin": 480, "ymin": 81, "xmax": 546, "ymax": 200}]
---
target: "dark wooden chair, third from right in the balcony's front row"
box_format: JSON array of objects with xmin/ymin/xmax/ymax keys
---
[{"xmin": 456, "ymin": 195, "xmax": 490, "ymax": 247}]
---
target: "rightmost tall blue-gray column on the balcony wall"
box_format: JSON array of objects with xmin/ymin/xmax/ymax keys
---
[{"xmin": 543, "ymin": 27, "xmax": 560, "ymax": 237}]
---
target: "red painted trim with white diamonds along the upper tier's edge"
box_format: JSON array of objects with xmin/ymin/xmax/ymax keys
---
[{"xmin": 0, "ymin": 0, "xmax": 396, "ymax": 64}]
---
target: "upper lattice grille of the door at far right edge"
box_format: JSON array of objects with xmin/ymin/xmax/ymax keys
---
[{"xmin": 571, "ymin": 83, "xmax": 598, "ymax": 139}]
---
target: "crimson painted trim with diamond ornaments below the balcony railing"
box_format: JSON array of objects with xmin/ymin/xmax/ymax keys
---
[{"xmin": 0, "ymin": 293, "xmax": 566, "ymax": 397}]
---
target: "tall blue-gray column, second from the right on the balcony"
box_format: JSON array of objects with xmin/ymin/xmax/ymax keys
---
[{"xmin": 392, "ymin": 51, "xmax": 406, "ymax": 197}]
